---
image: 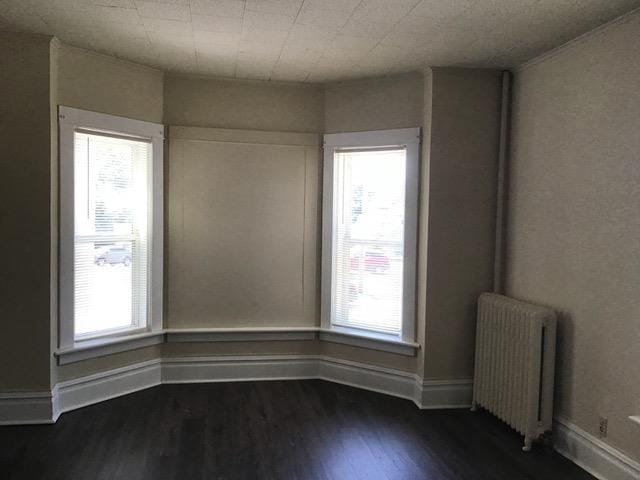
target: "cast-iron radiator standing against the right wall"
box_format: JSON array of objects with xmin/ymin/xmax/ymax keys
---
[{"xmin": 472, "ymin": 293, "xmax": 556, "ymax": 451}]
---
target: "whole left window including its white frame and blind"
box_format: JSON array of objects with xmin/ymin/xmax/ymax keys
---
[{"xmin": 60, "ymin": 107, "xmax": 163, "ymax": 349}]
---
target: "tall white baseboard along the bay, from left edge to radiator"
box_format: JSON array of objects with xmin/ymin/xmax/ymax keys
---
[{"xmin": 0, "ymin": 355, "xmax": 471, "ymax": 424}]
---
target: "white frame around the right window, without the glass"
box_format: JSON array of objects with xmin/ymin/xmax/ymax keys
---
[{"xmin": 320, "ymin": 128, "xmax": 420, "ymax": 355}]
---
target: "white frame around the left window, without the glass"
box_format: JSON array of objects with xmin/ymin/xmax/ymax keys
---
[{"xmin": 56, "ymin": 106, "xmax": 164, "ymax": 358}]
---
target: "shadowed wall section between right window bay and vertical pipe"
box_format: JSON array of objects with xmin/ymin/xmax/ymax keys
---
[{"xmin": 421, "ymin": 68, "xmax": 501, "ymax": 379}]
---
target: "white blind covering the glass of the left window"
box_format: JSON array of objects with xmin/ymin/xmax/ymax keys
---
[{"xmin": 73, "ymin": 130, "xmax": 152, "ymax": 339}]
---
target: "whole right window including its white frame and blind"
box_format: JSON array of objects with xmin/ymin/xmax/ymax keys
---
[{"xmin": 322, "ymin": 129, "xmax": 420, "ymax": 342}]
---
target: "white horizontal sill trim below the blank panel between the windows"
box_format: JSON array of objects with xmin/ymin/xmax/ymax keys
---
[{"xmin": 165, "ymin": 327, "xmax": 318, "ymax": 343}]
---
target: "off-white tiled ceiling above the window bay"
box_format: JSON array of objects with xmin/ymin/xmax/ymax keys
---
[{"xmin": 0, "ymin": 0, "xmax": 640, "ymax": 82}]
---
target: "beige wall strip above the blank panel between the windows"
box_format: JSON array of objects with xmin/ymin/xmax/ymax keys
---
[{"xmin": 164, "ymin": 75, "xmax": 324, "ymax": 133}]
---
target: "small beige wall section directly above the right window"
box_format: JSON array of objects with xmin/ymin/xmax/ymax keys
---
[{"xmin": 324, "ymin": 73, "xmax": 424, "ymax": 133}]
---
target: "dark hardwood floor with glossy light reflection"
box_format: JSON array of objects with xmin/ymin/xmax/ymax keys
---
[{"xmin": 0, "ymin": 380, "xmax": 593, "ymax": 480}]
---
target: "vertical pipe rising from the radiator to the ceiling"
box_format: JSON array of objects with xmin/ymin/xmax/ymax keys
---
[{"xmin": 493, "ymin": 70, "xmax": 511, "ymax": 293}]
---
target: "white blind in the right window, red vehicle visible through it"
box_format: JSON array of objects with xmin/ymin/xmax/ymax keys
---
[{"xmin": 332, "ymin": 147, "xmax": 407, "ymax": 335}]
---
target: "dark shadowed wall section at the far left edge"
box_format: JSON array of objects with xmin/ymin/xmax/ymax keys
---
[{"xmin": 0, "ymin": 33, "xmax": 55, "ymax": 390}]
